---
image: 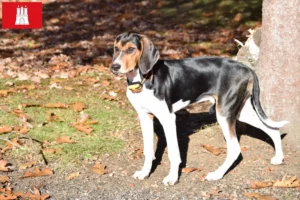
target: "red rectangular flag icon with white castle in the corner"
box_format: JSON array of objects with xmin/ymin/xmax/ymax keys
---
[{"xmin": 2, "ymin": 2, "xmax": 42, "ymax": 29}]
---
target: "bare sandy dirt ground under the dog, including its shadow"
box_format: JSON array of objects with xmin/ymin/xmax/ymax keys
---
[{"xmin": 3, "ymin": 103, "xmax": 300, "ymax": 200}]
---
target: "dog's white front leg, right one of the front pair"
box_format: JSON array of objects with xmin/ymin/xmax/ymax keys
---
[{"xmin": 158, "ymin": 113, "xmax": 181, "ymax": 185}]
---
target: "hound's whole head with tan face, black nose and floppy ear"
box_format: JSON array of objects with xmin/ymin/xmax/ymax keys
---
[{"xmin": 110, "ymin": 32, "xmax": 159, "ymax": 74}]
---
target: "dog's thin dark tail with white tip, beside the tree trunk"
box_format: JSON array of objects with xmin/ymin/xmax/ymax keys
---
[{"xmin": 251, "ymin": 72, "xmax": 289, "ymax": 129}]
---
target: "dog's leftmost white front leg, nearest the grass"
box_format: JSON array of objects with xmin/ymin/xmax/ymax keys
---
[{"xmin": 133, "ymin": 112, "xmax": 155, "ymax": 180}]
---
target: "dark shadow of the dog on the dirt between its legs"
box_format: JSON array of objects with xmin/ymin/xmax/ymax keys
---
[{"xmin": 151, "ymin": 101, "xmax": 286, "ymax": 178}]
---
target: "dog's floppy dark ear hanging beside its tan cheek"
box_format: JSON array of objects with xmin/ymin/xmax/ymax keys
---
[{"xmin": 138, "ymin": 35, "xmax": 159, "ymax": 74}]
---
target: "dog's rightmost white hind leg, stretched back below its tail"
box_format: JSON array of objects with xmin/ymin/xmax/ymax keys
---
[{"xmin": 238, "ymin": 98, "xmax": 283, "ymax": 165}]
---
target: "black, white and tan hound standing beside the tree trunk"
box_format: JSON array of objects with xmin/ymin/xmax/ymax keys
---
[{"xmin": 110, "ymin": 32, "xmax": 287, "ymax": 185}]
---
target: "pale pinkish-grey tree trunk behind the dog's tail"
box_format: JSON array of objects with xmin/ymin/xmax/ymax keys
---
[{"xmin": 256, "ymin": 0, "xmax": 300, "ymax": 150}]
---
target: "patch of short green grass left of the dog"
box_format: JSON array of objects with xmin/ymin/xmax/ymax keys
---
[{"xmin": 0, "ymin": 74, "xmax": 136, "ymax": 166}]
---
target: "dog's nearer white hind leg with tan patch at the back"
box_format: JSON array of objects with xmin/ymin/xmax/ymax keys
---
[{"xmin": 206, "ymin": 113, "xmax": 241, "ymax": 181}]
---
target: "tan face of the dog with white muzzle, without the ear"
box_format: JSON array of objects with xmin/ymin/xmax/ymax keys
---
[{"xmin": 114, "ymin": 41, "xmax": 142, "ymax": 73}]
